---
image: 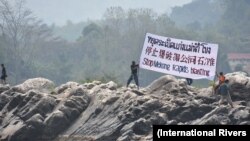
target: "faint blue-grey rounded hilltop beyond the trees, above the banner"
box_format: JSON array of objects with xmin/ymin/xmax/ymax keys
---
[{"xmin": 170, "ymin": 0, "xmax": 225, "ymax": 29}]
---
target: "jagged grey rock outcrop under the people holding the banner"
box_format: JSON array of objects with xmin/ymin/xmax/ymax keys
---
[{"xmin": 0, "ymin": 72, "xmax": 250, "ymax": 141}]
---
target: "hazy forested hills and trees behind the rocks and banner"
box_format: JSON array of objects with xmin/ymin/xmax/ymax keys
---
[{"xmin": 0, "ymin": 0, "xmax": 250, "ymax": 86}]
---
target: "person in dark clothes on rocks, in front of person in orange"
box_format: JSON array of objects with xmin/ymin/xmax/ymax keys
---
[{"xmin": 219, "ymin": 80, "xmax": 234, "ymax": 108}]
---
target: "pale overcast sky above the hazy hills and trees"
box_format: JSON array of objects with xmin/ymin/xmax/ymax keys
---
[{"xmin": 26, "ymin": 0, "xmax": 192, "ymax": 25}]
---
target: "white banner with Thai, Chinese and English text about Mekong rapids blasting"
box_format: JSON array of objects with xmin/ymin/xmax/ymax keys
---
[{"xmin": 140, "ymin": 33, "xmax": 218, "ymax": 80}]
